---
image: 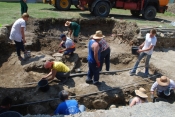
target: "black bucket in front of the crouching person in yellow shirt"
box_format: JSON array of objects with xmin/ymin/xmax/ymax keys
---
[{"xmin": 38, "ymin": 79, "xmax": 49, "ymax": 92}]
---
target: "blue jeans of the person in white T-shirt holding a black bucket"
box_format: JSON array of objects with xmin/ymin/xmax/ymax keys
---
[{"xmin": 131, "ymin": 52, "xmax": 151, "ymax": 72}]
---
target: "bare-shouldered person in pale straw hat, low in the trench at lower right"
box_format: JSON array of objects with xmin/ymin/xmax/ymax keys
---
[{"xmin": 129, "ymin": 88, "xmax": 148, "ymax": 107}]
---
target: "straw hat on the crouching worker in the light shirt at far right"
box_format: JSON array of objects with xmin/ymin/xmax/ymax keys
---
[{"xmin": 156, "ymin": 76, "xmax": 170, "ymax": 86}]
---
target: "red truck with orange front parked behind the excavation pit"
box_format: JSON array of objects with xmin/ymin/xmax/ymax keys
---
[{"xmin": 79, "ymin": 0, "xmax": 169, "ymax": 20}]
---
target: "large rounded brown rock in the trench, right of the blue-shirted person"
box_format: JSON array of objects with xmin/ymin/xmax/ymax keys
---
[{"xmin": 92, "ymin": 99, "xmax": 108, "ymax": 109}]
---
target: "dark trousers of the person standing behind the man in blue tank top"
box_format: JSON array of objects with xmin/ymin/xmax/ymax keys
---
[{"xmin": 100, "ymin": 48, "xmax": 111, "ymax": 71}]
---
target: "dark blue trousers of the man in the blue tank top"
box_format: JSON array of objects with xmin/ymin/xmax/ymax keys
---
[{"xmin": 87, "ymin": 61, "xmax": 99, "ymax": 83}]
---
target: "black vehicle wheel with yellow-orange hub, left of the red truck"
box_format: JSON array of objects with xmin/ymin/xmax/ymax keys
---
[{"xmin": 55, "ymin": 0, "xmax": 71, "ymax": 11}]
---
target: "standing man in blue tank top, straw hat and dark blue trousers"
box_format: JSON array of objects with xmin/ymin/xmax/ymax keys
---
[{"xmin": 86, "ymin": 30, "xmax": 104, "ymax": 85}]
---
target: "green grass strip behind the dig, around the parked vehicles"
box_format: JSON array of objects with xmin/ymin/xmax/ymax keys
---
[{"xmin": 0, "ymin": 2, "xmax": 175, "ymax": 27}]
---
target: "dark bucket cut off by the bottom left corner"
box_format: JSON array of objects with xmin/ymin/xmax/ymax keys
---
[{"xmin": 0, "ymin": 111, "xmax": 22, "ymax": 117}]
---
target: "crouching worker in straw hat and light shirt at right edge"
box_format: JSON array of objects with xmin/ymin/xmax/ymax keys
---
[{"xmin": 151, "ymin": 76, "xmax": 175, "ymax": 99}]
